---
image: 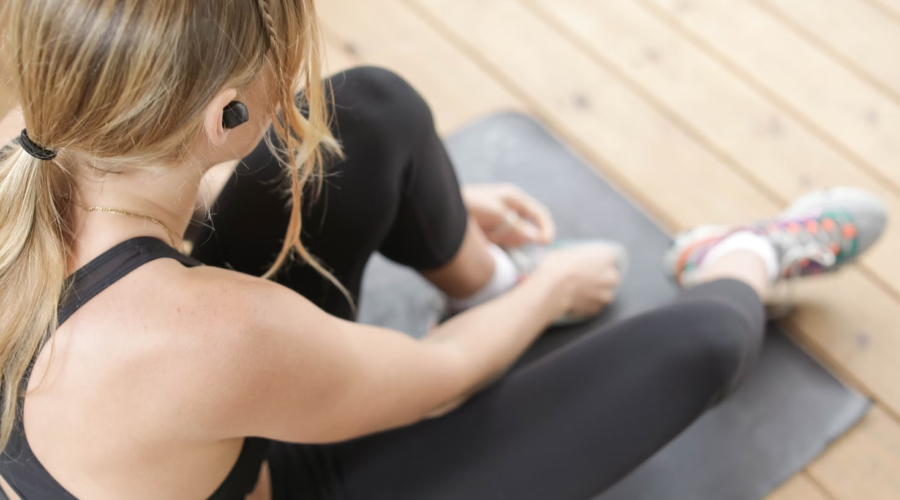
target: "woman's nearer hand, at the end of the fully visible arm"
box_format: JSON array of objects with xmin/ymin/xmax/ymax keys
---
[{"xmin": 529, "ymin": 245, "xmax": 622, "ymax": 316}]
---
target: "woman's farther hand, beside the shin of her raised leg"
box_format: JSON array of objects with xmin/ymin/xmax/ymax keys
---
[{"xmin": 462, "ymin": 184, "xmax": 556, "ymax": 248}]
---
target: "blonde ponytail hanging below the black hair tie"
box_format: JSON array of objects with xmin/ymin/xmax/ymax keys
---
[{"xmin": 0, "ymin": 145, "xmax": 68, "ymax": 450}]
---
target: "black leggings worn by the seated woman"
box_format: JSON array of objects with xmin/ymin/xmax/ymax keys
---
[{"xmin": 195, "ymin": 68, "xmax": 765, "ymax": 500}]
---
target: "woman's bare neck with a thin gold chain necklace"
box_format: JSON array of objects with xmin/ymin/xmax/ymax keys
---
[{"xmin": 70, "ymin": 161, "xmax": 203, "ymax": 271}]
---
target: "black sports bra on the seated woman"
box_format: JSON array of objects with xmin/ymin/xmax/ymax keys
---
[{"xmin": 0, "ymin": 237, "xmax": 269, "ymax": 500}]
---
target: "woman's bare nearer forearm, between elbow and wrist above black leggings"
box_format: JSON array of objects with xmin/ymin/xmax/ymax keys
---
[{"xmin": 423, "ymin": 276, "xmax": 564, "ymax": 417}]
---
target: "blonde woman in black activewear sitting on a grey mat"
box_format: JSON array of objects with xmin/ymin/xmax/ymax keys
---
[{"xmin": 0, "ymin": 0, "xmax": 885, "ymax": 500}]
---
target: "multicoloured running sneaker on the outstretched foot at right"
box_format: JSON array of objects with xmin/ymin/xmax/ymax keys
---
[{"xmin": 665, "ymin": 187, "xmax": 888, "ymax": 286}]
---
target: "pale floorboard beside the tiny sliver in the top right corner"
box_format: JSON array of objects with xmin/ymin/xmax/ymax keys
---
[{"xmin": 754, "ymin": 0, "xmax": 900, "ymax": 102}]
